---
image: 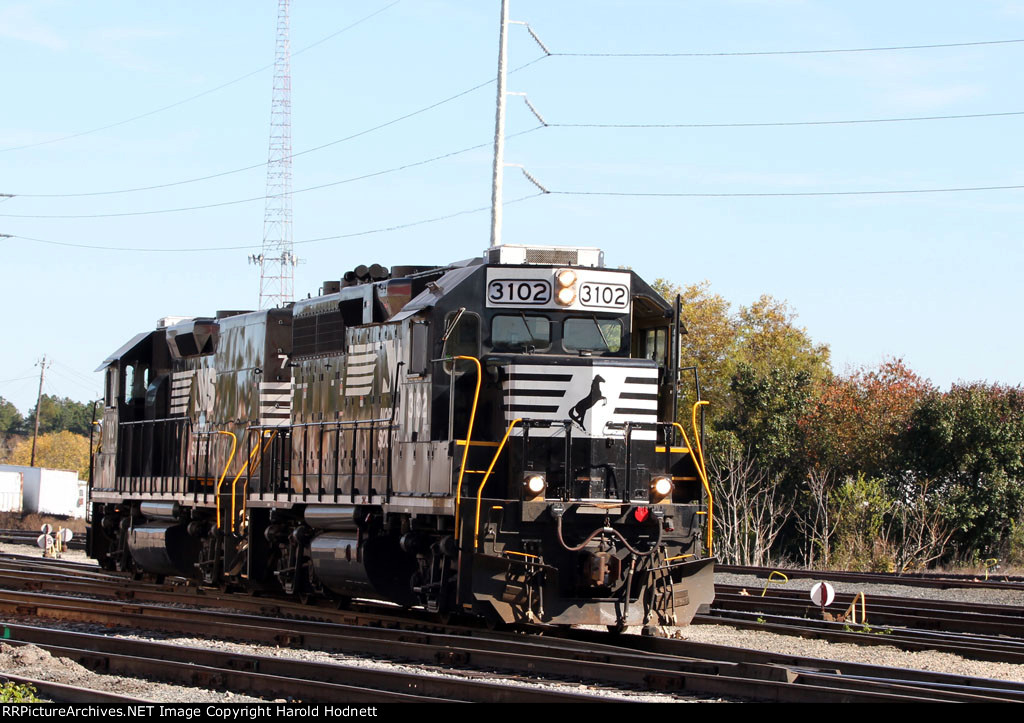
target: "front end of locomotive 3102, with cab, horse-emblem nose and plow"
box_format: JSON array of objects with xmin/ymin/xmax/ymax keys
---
[{"xmin": 419, "ymin": 247, "xmax": 713, "ymax": 627}]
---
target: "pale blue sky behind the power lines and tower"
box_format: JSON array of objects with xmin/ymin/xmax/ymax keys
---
[{"xmin": 0, "ymin": 0, "xmax": 1024, "ymax": 412}]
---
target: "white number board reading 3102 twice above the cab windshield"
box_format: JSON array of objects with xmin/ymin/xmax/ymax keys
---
[{"xmin": 486, "ymin": 266, "xmax": 631, "ymax": 312}]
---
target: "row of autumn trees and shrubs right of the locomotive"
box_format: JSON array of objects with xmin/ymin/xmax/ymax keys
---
[{"xmin": 654, "ymin": 272, "xmax": 1024, "ymax": 569}]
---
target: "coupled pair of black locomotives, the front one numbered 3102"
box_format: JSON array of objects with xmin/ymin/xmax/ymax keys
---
[{"xmin": 88, "ymin": 241, "xmax": 714, "ymax": 628}]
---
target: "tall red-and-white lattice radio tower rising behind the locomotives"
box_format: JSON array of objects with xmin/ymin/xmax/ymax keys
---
[{"xmin": 250, "ymin": 0, "xmax": 298, "ymax": 309}]
